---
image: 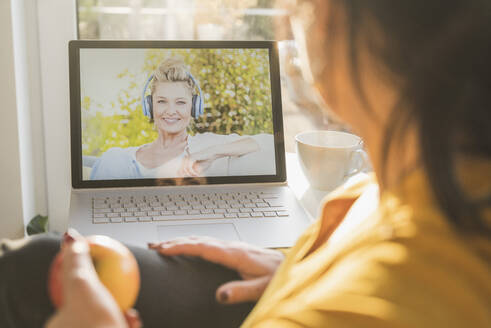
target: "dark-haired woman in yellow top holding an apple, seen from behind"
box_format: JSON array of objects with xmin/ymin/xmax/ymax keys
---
[{"xmin": 0, "ymin": 0, "xmax": 491, "ymax": 327}]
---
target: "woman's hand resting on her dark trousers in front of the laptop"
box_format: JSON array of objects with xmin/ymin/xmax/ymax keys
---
[{"xmin": 148, "ymin": 237, "xmax": 284, "ymax": 304}]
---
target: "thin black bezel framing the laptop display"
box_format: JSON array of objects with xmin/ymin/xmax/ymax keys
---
[{"xmin": 68, "ymin": 40, "xmax": 286, "ymax": 189}]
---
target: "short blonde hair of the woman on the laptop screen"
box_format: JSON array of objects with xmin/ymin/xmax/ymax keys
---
[{"xmin": 150, "ymin": 57, "xmax": 195, "ymax": 95}]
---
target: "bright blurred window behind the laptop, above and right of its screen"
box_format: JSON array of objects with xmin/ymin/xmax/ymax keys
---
[{"xmin": 77, "ymin": 0, "xmax": 327, "ymax": 152}]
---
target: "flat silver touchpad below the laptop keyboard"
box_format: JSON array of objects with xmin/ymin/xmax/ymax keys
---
[{"xmin": 157, "ymin": 223, "xmax": 240, "ymax": 241}]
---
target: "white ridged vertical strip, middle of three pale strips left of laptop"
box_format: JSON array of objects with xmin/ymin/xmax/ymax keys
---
[{"xmin": 11, "ymin": 0, "xmax": 47, "ymax": 229}]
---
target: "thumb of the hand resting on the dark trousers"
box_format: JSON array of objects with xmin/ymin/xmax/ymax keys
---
[{"xmin": 216, "ymin": 276, "xmax": 271, "ymax": 304}]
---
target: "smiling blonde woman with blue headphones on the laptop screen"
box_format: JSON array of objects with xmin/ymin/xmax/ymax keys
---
[{"xmin": 90, "ymin": 58, "xmax": 260, "ymax": 180}]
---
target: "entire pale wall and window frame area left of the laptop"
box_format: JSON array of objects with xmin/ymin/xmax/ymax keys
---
[{"xmin": 0, "ymin": 0, "xmax": 76, "ymax": 238}]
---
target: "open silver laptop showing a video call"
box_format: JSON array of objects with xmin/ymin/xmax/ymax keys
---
[{"xmin": 69, "ymin": 41, "xmax": 310, "ymax": 248}]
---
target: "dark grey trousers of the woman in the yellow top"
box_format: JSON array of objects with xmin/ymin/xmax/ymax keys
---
[{"xmin": 0, "ymin": 234, "xmax": 254, "ymax": 328}]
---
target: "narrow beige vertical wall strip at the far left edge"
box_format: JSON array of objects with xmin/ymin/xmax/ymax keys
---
[{"xmin": 0, "ymin": 1, "xmax": 24, "ymax": 238}]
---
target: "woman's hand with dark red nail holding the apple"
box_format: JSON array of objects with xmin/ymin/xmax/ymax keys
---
[{"xmin": 46, "ymin": 231, "xmax": 141, "ymax": 328}]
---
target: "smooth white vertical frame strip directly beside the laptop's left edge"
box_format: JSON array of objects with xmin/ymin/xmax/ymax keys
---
[{"xmin": 37, "ymin": 0, "xmax": 77, "ymax": 232}]
